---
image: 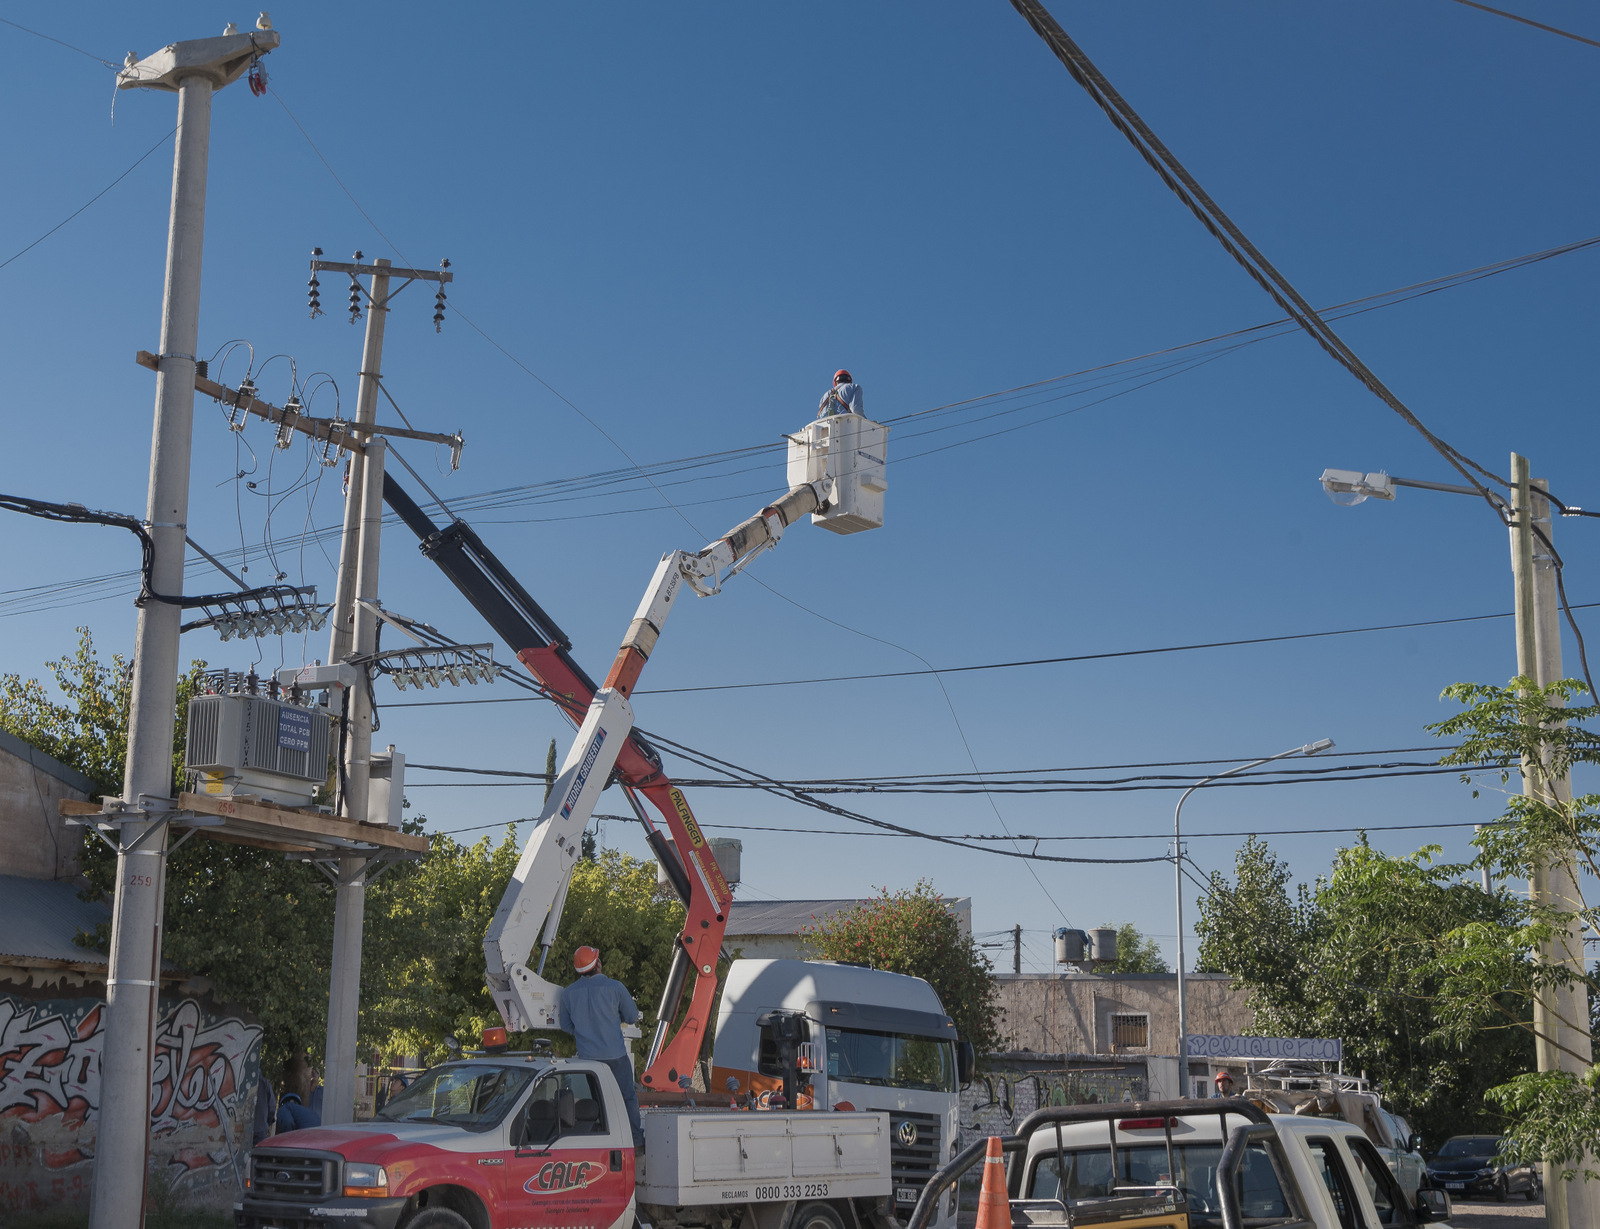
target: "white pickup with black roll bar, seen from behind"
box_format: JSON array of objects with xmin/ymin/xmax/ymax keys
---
[{"xmin": 906, "ymin": 1098, "xmax": 1450, "ymax": 1229}]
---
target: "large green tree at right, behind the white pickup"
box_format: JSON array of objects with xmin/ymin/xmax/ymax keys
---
[{"xmin": 1195, "ymin": 837, "xmax": 1533, "ymax": 1143}]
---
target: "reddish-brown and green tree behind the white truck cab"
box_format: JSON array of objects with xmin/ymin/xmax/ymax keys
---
[{"xmin": 803, "ymin": 880, "xmax": 1003, "ymax": 1055}]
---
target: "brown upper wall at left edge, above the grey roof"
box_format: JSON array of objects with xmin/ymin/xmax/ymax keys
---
[{"xmin": 0, "ymin": 730, "xmax": 94, "ymax": 880}]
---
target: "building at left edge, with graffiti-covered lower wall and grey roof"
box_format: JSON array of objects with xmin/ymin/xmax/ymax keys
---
[{"xmin": 0, "ymin": 731, "xmax": 261, "ymax": 1221}]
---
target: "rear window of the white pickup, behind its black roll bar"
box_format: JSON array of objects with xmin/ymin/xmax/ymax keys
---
[{"xmin": 1027, "ymin": 1141, "xmax": 1290, "ymax": 1224}]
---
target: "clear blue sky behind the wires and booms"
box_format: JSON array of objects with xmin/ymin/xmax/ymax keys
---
[{"xmin": 0, "ymin": 0, "xmax": 1600, "ymax": 970}]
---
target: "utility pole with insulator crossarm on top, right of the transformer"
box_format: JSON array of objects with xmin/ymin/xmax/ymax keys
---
[{"xmin": 322, "ymin": 264, "xmax": 389, "ymax": 1125}]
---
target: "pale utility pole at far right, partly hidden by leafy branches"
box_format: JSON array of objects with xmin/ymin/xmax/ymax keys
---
[{"xmin": 1510, "ymin": 453, "xmax": 1600, "ymax": 1229}]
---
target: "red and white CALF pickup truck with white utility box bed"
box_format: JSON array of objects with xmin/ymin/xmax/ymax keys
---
[{"xmin": 243, "ymin": 1053, "xmax": 894, "ymax": 1229}]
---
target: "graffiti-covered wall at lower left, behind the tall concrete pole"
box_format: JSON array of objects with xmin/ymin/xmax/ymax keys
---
[{"xmin": 0, "ymin": 984, "xmax": 261, "ymax": 1213}]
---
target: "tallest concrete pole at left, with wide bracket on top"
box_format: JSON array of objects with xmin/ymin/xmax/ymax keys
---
[{"xmin": 90, "ymin": 30, "xmax": 278, "ymax": 1229}]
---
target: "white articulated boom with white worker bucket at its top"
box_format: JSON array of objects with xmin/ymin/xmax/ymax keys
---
[{"xmin": 483, "ymin": 414, "xmax": 888, "ymax": 1048}]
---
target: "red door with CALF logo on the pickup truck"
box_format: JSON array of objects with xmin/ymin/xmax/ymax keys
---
[{"xmin": 501, "ymin": 1069, "xmax": 634, "ymax": 1229}]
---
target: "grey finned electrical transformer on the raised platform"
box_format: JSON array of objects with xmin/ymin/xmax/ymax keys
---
[{"xmin": 184, "ymin": 693, "xmax": 333, "ymax": 807}]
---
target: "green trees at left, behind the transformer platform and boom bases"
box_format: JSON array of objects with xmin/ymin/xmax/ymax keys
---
[{"xmin": 0, "ymin": 640, "xmax": 683, "ymax": 1072}]
